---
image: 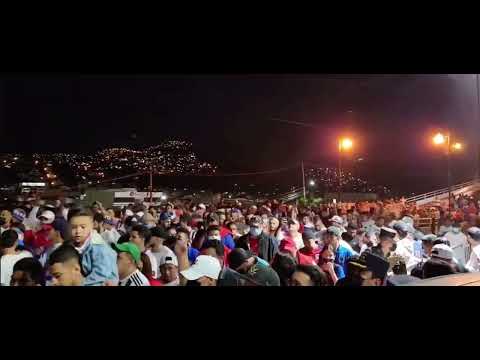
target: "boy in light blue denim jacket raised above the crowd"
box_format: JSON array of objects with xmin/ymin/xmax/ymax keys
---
[{"xmin": 68, "ymin": 208, "xmax": 118, "ymax": 286}]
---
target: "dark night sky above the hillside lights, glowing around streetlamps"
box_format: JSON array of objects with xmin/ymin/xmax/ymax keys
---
[{"xmin": 0, "ymin": 75, "xmax": 480, "ymax": 195}]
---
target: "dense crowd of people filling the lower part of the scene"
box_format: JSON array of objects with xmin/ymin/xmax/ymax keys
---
[{"xmin": 0, "ymin": 196, "xmax": 480, "ymax": 286}]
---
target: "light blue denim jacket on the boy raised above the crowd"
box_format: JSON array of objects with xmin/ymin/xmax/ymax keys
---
[{"xmin": 82, "ymin": 231, "xmax": 118, "ymax": 286}]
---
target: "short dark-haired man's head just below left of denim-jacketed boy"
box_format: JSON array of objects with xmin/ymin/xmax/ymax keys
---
[{"xmin": 48, "ymin": 244, "xmax": 84, "ymax": 286}]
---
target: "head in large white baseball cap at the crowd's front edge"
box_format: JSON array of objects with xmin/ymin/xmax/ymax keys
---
[{"xmin": 180, "ymin": 255, "xmax": 222, "ymax": 286}]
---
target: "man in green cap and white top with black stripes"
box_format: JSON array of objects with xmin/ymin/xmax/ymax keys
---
[{"xmin": 112, "ymin": 242, "xmax": 150, "ymax": 286}]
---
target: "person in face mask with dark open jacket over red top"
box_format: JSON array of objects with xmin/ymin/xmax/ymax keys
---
[{"xmin": 237, "ymin": 216, "xmax": 278, "ymax": 263}]
